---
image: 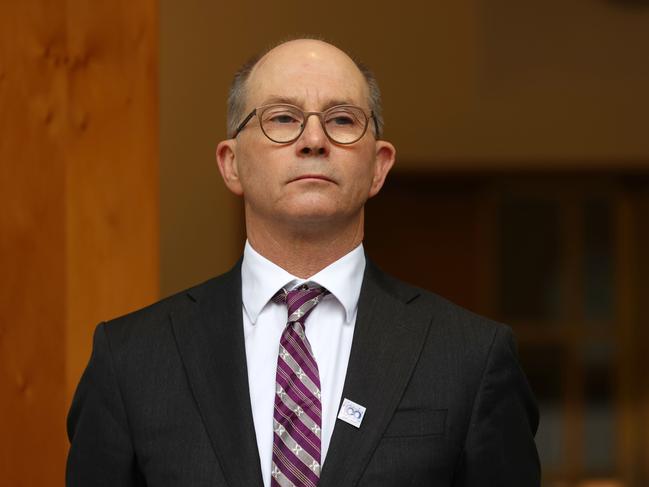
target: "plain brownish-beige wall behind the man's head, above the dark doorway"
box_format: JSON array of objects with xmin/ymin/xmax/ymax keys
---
[{"xmin": 160, "ymin": 0, "xmax": 649, "ymax": 294}]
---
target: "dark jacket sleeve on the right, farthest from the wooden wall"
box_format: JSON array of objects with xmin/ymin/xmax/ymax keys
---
[{"xmin": 453, "ymin": 327, "xmax": 541, "ymax": 487}]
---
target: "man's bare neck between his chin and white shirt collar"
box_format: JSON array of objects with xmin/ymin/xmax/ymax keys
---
[{"xmin": 246, "ymin": 212, "xmax": 363, "ymax": 279}]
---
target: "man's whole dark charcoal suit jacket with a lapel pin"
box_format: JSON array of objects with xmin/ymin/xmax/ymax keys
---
[{"xmin": 67, "ymin": 261, "xmax": 540, "ymax": 487}]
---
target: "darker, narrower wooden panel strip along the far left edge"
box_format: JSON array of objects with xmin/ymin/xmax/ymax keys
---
[{"xmin": 0, "ymin": 1, "xmax": 66, "ymax": 486}]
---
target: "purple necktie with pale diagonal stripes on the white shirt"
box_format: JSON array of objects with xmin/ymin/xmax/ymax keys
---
[{"xmin": 270, "ymin": 285, "xmax": 329, "ymax": 487}]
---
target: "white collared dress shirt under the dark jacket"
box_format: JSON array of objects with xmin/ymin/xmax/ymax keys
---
[{"xmin": 241, "ymin": 242, "xmax": 365, "ymax": 487}]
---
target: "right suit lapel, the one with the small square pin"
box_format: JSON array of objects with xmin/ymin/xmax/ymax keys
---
[{"xmin": 319, "ymin": 261, "xmax": 430, "ymax": 487}]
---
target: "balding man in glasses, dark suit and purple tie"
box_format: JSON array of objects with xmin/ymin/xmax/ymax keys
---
[{"xmin": 67, "ymin": 39, "xmax": 540, "ymax": 487}]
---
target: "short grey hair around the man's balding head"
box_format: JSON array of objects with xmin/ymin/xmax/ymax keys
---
[{"xmin": 227, "ymin": 37, "xmax": 383, "ymax": 138}]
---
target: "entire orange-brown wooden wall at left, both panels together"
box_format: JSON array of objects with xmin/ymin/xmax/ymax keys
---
[{"xmin": 0, "ymin": 0, "xmax": 159, "ymax": 487}]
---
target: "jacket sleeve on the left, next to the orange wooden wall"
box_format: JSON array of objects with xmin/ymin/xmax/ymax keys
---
[{"xmin": 66, "ymin": 324, "xmax": 144, "ymax": 487}]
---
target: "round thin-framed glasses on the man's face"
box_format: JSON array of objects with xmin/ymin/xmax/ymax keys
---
[{"xmin": 232, "ymin": 104, "xmax": 378, "ymax": 145}]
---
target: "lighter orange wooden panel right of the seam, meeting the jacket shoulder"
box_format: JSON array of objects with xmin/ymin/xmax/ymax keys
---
[{"xmin": 66, "ymin": 0, "xmax": 159, "ymax": 408}]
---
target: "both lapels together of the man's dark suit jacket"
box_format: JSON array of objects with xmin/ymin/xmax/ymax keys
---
[{"xmin": 171, "ymin": 260, "xmax": 430, "ymax": 487}]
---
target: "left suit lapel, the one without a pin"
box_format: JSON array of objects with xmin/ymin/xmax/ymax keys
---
[{"xmin": 171, "ymin": 262, "xmax": 262, "ymax": 487}]
